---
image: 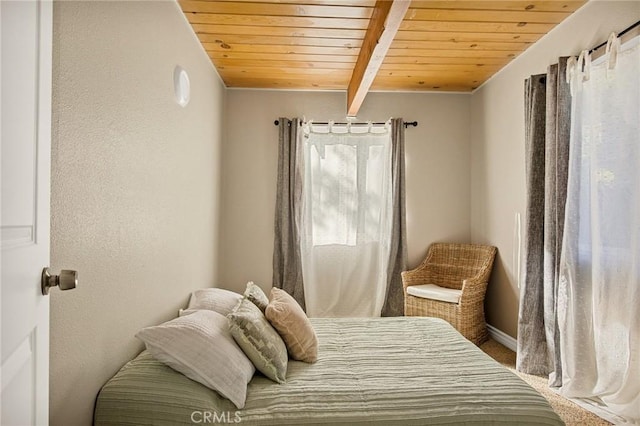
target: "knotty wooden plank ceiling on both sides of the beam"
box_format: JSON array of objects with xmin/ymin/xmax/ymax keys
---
[{"xmin": 179, "ymin": 0, "xmax": 585, "ymax": 92}]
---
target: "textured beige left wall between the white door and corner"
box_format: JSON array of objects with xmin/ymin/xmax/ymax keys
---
[{"xmin": 50, "ymin": 1, "xmax": 225, "ymax": 425}]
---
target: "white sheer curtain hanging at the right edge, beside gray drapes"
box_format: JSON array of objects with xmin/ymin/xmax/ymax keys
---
[{"xmin": 558, "ymin": 37, "xmax": 640, "ymax": 424}]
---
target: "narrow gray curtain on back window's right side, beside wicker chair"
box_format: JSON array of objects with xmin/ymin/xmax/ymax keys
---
[{"xmin": 382, "ymin": 118, "xmax": 407, "ymax": 317}]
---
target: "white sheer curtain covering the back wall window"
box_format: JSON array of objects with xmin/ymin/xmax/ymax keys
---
[{"xmin": 299, "ymin": 123, "xmax": 393, "ymax": 317}]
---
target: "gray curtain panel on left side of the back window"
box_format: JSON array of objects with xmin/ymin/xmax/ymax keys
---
[{"xmin": 273, "ymin": 117, "xmax": 306, "ymax": 310}]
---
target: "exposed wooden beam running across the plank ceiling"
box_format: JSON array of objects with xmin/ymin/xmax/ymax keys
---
[{"xmin": 347, "ymin": 0, "xmax": 411, "ymax": 117}]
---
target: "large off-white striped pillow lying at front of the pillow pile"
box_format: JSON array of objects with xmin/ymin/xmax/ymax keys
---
[{"xmin": 136, "ymin": 310, "xmax": 255, "ymax": 408}]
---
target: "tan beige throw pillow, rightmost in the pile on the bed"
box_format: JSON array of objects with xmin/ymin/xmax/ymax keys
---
[{"xmin": 265, "ymin": 287, "xmax": 318, "ymax": 362}]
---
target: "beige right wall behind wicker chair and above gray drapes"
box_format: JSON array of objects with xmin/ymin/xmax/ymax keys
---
[{"xmin": 471, "ymin": 1, "xmax": 640, "ymax": 336}]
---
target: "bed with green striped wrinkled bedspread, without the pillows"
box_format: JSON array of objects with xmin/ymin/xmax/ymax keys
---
[{"xmin": 94, "ymin": 317, "xmax": 563, "ymax": 426}]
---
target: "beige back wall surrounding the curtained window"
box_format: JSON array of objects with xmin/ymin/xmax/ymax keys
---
[{"xmin": 219, "ymin": 90, "xmax": 470, "ymax": 290}]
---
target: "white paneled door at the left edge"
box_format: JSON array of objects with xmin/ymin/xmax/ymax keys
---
[{"xmin": 0, "ymin": 0, "xmax": 52, "ymax": 426}]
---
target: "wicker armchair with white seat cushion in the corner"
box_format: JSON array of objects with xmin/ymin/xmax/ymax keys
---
[{"xmin": 402, "ymin": 243, "xmax": 496, "ymax": 345}]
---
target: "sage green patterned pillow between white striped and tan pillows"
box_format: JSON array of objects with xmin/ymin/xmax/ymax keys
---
[{"xmin": 227, "ymin": 298, "xmax": 289, "ymax": 383}]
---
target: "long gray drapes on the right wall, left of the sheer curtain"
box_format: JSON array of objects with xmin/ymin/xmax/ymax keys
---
[{"xmin": 516, "ymin": 58, "xmax": 571, "ymax": 386}]
